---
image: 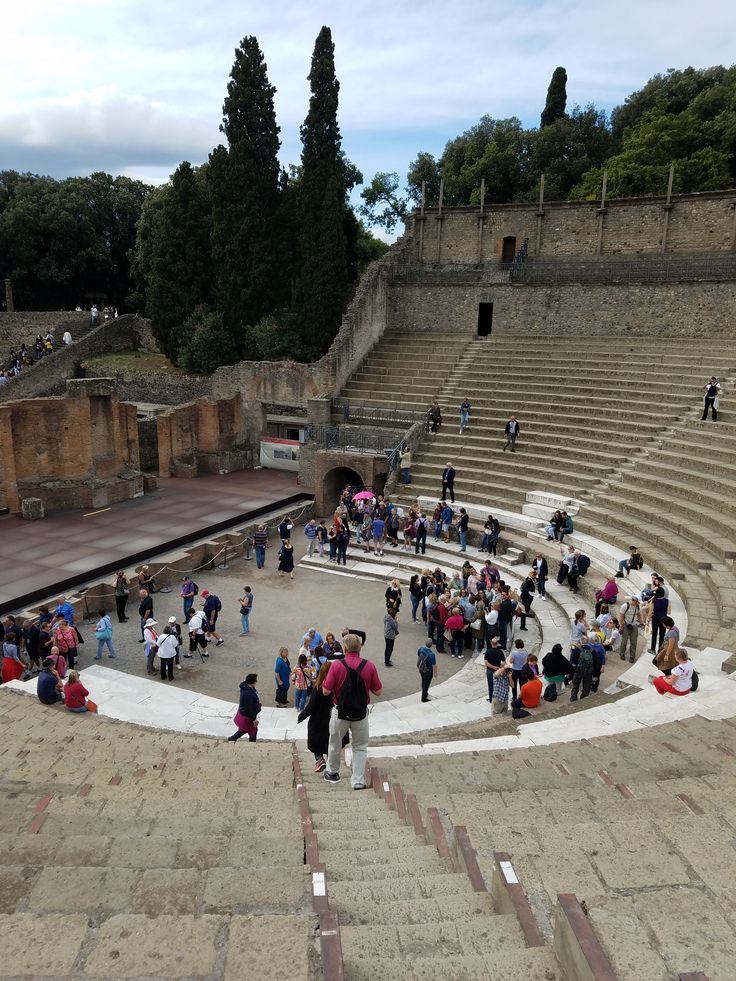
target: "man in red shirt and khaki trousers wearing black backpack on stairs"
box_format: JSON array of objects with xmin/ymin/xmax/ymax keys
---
[{"xmin": 322, "ymin": 634, "xmax": 383, "ymax": 790}]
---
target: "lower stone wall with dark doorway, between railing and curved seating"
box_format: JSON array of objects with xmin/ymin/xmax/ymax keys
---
[{"xmin": 391, "ymin": 283, "xmax": 736, "ymax": 337}]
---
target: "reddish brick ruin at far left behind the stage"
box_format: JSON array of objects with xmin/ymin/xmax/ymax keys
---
[{"xmin": 0, "ymin": 379, "xmax": 142, "ymax": 511}]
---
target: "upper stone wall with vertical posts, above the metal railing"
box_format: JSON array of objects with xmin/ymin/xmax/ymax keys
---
[{"xmin": 408, "ymin": 191, "xmax": 736, "ymax": 263}]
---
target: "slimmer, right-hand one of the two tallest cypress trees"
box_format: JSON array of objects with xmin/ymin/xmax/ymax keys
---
[{"xmin": 299, "ymin": 27, "xmax": 348, "ymax": 357}]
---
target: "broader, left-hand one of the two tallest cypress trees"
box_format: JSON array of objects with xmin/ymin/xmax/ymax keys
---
[{"xmin": 210, "ymin": 37, "xmax": 281, "ymax": 340}]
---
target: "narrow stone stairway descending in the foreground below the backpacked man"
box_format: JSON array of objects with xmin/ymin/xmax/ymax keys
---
[{"xmin": 301, "ymin": 754, "xmax": 567, "ymax": 981}]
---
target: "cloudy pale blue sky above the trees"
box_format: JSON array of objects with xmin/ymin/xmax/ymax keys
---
[{"xmin": 0, "ymin": 0, "xmax": 736, "ymax": 199}]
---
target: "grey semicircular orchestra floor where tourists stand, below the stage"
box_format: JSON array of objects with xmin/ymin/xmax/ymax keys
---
[{"xmin": 72, "ymin": 528, "xmax": 468, "ymax": 705}]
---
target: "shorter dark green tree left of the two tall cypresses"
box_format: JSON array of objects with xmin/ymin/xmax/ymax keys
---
[{"xmin": 139, "ymin": 160, "xmax": 212, "ymax": 361}]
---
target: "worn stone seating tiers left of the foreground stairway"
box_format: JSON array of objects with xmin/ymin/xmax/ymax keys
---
[{"xmin": 0, "ymin": 693, "xmax": 320, "ymax": 981}]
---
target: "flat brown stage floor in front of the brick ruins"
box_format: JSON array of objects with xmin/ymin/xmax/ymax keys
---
[{"xmin": 0, "ymin": 470, "xmax": 299, "ymax": 613}]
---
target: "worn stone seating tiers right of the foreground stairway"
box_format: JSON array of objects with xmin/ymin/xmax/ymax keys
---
[{"xmin": 382, "ymin": 718, "xmax": 736, "ymax": 981}]
